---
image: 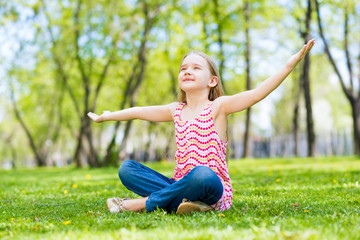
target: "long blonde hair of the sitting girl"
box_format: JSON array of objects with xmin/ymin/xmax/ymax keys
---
[{"xmin": 178, "ymin": 51, "xmax": 224, "ymax": 103}]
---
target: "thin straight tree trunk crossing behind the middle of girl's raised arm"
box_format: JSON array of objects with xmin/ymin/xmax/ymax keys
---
[{"xmin": 243, "ymin": 1, "xmax": 251, "ymax": 158}]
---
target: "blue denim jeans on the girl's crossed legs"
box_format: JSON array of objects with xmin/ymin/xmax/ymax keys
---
[{"xmin": 119, "ymin": 160, "xmax": 223, "ymax": 212}]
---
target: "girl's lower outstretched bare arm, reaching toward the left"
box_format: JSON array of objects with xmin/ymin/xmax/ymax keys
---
[{"xmin": 87, "ymin": 102, "xmax": 178, "ymax": 123}]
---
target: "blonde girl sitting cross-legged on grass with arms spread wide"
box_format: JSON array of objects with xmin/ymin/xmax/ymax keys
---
[{"xmin": 88, "ymin": 40, "xmax": 315, "ymax": 214}]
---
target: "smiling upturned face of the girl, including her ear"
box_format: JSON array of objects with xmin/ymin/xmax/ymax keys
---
[{"xmin": 178, "ymin": 54, "xmax": 217, "ymax": 92}]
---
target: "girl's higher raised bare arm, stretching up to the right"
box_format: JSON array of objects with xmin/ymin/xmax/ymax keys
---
[{"xmin": 219, "ymin": 39, "xmax": 315, "ymax": 115}]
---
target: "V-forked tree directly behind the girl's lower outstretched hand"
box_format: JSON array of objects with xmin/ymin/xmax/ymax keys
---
[{"xmin": 42, "ymin": 0, "xmax": 143, "ymax": 167}]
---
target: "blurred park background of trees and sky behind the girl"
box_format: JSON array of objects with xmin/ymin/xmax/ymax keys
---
[{"xmin": 0, "ymin": 0, "xmax": 360, "ymax": 169}]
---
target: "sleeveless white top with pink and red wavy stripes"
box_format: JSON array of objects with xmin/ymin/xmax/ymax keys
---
[{"xmin": 173, "ymin": 103, "xmax": 233, "ymax": 211}]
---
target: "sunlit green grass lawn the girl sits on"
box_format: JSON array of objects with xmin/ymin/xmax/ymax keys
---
[{"xmin": 0, "ymin": 157, "xmax": 360, "ymax": 240}]
